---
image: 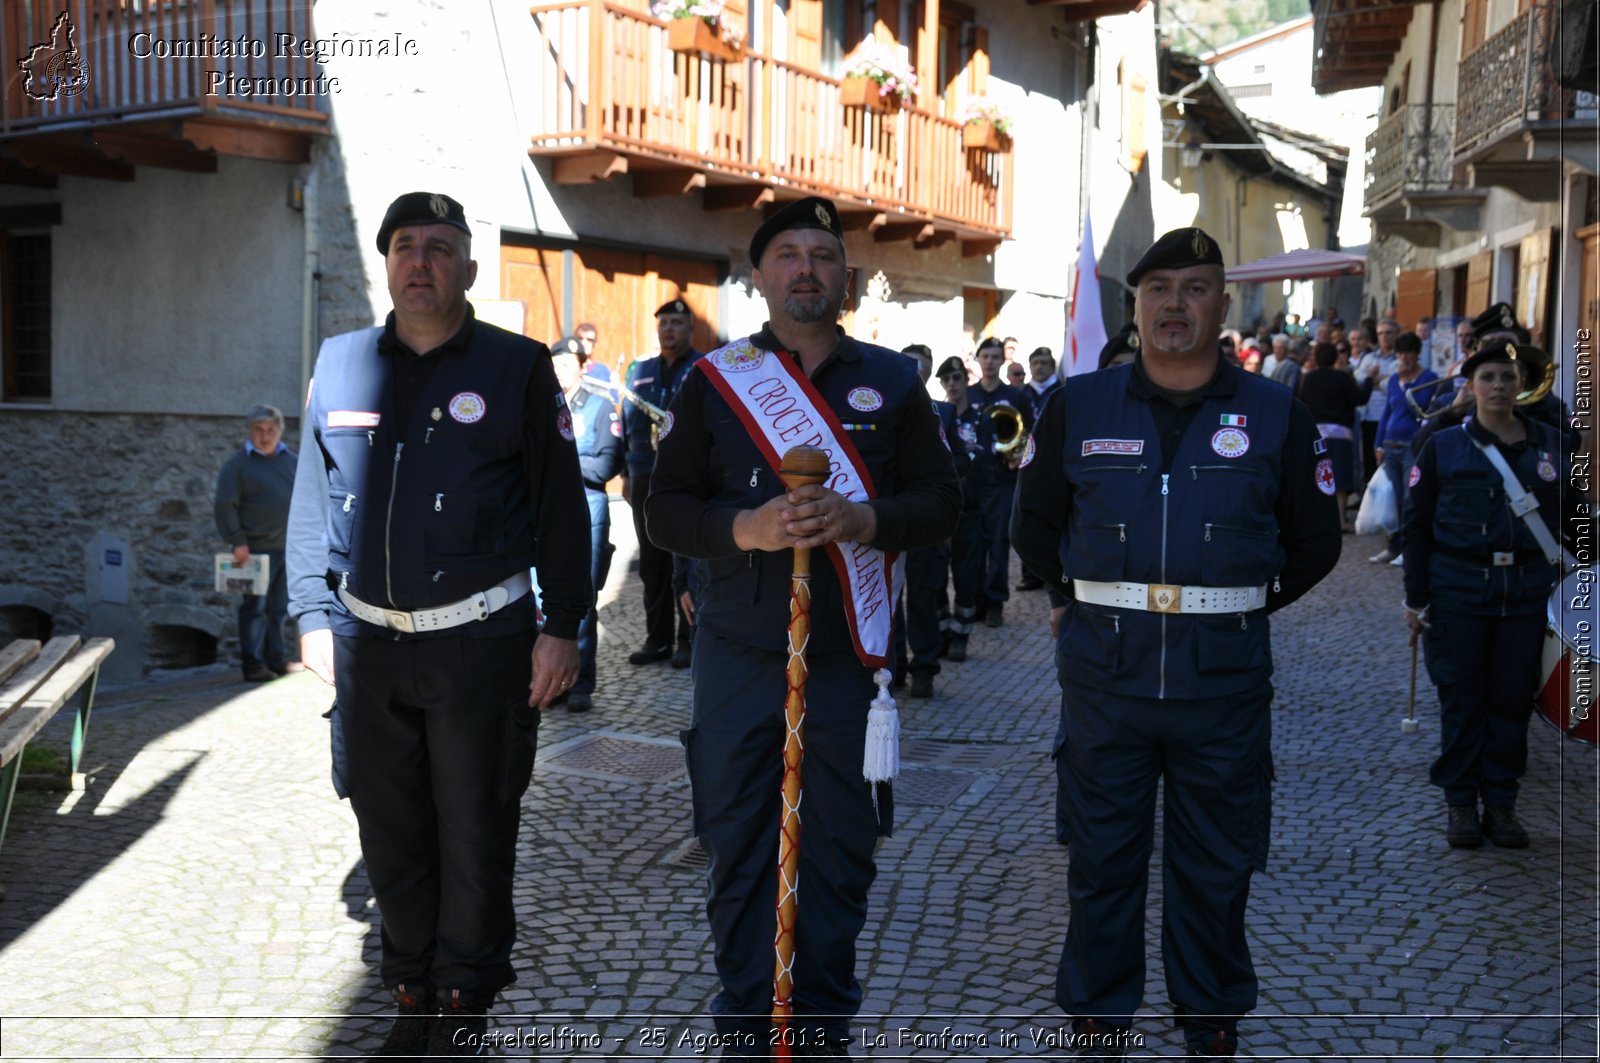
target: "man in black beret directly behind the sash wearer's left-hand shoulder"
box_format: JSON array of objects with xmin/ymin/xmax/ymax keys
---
[{"xmin": 622, "ymin": 296, "xmax": 701, "ymax": 668}]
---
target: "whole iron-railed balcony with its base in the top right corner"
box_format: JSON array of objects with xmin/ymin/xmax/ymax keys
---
[{"xmin": 1454, "ymin": 3, "xmax": 1600, "ymax": 202}]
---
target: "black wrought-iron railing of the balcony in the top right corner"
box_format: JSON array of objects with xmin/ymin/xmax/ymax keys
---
[{"xmin": 1456, "ymin": 3, "xmax": 1594, "ymax": 155}]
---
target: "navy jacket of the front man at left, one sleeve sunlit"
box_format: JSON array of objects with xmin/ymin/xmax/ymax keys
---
[{"xmin": 286, "ymin": 311, "xmax": 594, "ymax": 639}]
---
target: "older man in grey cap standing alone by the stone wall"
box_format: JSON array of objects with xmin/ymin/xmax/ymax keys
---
[{"xmin": 211, "ymin": 398, "xmax": 298, "ymax": 684}]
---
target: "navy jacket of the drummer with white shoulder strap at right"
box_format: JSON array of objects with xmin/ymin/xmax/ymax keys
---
[{"xmin": 1403, "ymin": 411, "xmax": 1584, "ymax": 616}]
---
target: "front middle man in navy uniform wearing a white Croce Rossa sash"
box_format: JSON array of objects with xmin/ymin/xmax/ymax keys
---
[{"xmin": 646, "ymin": 197, "xmax": 960, "ymax": 1058}]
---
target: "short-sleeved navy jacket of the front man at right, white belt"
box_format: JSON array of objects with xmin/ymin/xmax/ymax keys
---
[{"xmin": 1013, "ymin": 360, "xmax": 1341, "ymax": 698}]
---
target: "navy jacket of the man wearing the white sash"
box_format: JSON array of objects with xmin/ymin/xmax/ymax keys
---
[{"xmin": 645, "ymin": 328, "xmax": 962, "ymax": 653}]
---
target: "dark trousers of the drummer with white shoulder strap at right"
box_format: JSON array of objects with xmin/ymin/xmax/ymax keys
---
[{"xmin": 1422, "ymin": 607, "xmax": 1544, "ymax": 807}]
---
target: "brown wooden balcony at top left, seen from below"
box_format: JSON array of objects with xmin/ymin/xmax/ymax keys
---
[{"xmin": 0, "ymin": 0, "xmax": 328, "ymax": 184}]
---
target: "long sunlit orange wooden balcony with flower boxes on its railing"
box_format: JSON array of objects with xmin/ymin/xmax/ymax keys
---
[{"xmin": 528, "ymin": 0, "xmax": 1011, "ymax": 255}]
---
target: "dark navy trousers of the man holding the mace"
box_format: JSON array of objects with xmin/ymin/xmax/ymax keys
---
[{"xmin": 682, "ymin": 631, "xmax": 894, "ymax": 1057}]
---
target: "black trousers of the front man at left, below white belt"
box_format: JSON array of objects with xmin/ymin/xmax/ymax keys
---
[{"xmin": 334, "ymin": 632, "xmax": 539, "ymax": 1007}]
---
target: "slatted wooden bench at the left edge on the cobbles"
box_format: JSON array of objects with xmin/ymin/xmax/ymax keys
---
[{"xmin": 0, "ymin": 636, "xmax": 117, "ymax": 845}]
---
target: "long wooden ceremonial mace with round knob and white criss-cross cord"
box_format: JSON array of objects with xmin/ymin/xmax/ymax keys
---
[{"xmin": 773, "ymin": 447, "xmax": 827, "ymax": 1060}]
